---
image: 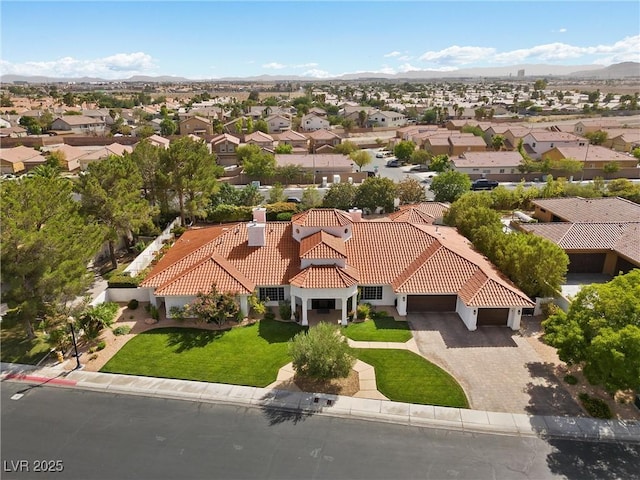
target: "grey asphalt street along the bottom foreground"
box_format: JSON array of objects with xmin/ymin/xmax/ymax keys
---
[{"xmin": 1, "ymin": 381, "xmax": 640, "ymax": 479}]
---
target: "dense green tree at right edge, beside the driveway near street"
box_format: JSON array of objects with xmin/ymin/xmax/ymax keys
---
[{"xmin": 543, "ymin": 269, "xmax": 640, "ymax": 391}]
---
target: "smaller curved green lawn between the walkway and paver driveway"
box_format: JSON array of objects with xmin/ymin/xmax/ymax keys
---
[{"xmin": 355, "ymin": 348, "xmax": 469, "ymax": 408}]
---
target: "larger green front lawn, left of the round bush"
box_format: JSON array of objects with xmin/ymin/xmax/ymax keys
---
[{"xmin": 101, "ymin": 320, "xmax": 303, "ymax": 387}]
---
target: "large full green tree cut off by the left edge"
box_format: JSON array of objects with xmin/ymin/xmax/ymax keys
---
[{"xmin": 0, "ymin": 176, "xmax": 103, "ymax": 337}]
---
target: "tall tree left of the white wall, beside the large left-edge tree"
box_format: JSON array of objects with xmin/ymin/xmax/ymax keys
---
[{"xmin": 76, "ymin": 155, "xmax": 156, "ymax": 268}]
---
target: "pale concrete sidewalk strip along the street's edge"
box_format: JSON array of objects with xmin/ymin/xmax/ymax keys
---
[{"xmin": 0, "ymin": 363, "xmax": 640, "ymax": 443}]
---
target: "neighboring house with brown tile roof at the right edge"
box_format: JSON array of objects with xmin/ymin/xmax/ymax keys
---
[{"xmin": 518, "ymin": 197, "xmax": 640, "ymax": 275}]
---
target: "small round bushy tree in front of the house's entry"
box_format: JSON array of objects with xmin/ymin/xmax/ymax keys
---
[{"xmin": 289, "ymin": 323, "xmax": 355, "ymax": 380}]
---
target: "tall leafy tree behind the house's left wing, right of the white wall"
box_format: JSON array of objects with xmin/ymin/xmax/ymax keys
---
[{"xmin": 161, "ymin": 137, "xmax": 223, "ymax": 224}]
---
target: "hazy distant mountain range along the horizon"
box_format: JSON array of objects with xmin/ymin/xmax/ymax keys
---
[{"xmin": 0, "ymin": 62, "xmax": 640, "ymax": 83}]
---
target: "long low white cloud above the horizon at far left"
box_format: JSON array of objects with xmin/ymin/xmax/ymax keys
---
[{"xmin": 0, "ymin": 52, "xmax": 157, "ymax": 79}]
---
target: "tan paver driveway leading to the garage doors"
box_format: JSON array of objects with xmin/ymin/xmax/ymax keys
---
[{"xmin": 407, "ymin": 313, "xmax": 582, "ymax": 415}]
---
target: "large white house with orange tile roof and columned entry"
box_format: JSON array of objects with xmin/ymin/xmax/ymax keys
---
[{"xmin": 141, "ymin": 208, "xmax": 533, "ymax": 330}]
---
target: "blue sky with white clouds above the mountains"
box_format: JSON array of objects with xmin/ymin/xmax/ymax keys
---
[{"xmin": 0, "ymin": 0, "xmax": 640, "ymax": 79}]
